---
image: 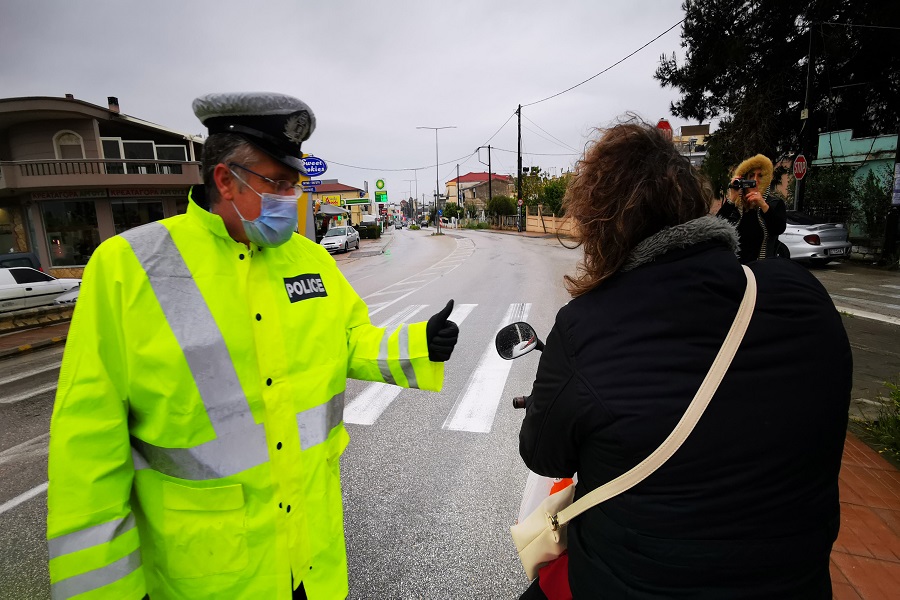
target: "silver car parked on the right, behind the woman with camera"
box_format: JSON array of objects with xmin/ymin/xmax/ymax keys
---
[{"xmin": 778, "ymin": 210, "xmax": 851, "ymax": 265}]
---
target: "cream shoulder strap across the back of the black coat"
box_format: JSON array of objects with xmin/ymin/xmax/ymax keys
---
[{"xmin": 555, "ymin": 266, "xmax": 756, "ymax": 526}]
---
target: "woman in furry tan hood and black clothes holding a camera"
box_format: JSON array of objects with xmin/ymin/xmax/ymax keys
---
[{"xmin": 718, "ymin": 154, "xmax": 786, "ymax": 264}]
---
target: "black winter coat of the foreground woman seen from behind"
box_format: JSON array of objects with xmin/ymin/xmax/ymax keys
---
[{"xmin": 520, "ymin": 217, "xmax": 852, "ymax": 599}]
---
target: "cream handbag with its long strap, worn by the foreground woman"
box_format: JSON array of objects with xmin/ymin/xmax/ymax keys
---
[{"xmin": 510, "ymin": 266, "xmax": 756, "ymax": 580}]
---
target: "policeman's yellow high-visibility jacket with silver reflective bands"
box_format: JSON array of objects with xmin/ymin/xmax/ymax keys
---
[{"xmin": 47, "ymin": 201, "xmax": 444, "ymax": 600}]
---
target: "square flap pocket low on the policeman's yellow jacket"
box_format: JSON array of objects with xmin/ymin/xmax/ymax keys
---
[{"xmin": 163, "ymin": 481, "xmax": 249, "ymax": 579}]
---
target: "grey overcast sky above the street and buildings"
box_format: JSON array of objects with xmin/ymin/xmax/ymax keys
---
[{"xmin": 0, "ymin": 0, "xmax": 690, "ymax": 201}]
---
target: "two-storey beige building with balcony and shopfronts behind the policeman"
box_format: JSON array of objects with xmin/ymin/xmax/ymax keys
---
[{"xmin": 0, "ymin": 95, "xmax": 203, "ymax": 277}]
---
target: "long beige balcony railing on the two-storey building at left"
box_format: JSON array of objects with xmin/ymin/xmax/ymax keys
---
[{"xmin": 0, "ymin": 159, "xmax": 202, "ymax": 191}]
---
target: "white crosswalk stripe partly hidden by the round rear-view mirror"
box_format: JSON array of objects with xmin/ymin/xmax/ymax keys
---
[{"xmin": 443, "ymin": 304, "xmax": 531, "ymax": 433}]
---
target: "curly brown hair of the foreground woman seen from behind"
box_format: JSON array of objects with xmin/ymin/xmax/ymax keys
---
[{"xmin": 563, "ymin": 116, "xmax": 713, "ymax": 297}]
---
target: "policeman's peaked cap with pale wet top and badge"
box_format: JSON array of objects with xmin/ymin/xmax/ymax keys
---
[{"xmin": 191, "ymin": 92, "xmax": 316, "ymax": 175}]
